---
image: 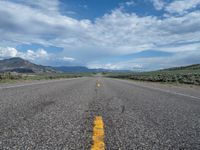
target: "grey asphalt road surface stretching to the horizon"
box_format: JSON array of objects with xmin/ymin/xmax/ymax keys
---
[{"xmin": 0, "ymin": 77, "xmax": 200, "ymax": 150}]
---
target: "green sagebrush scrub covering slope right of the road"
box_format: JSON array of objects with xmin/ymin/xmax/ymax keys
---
[{"xmin": 106, "ymin": 65, "xmax": 200, "ymax": 85}]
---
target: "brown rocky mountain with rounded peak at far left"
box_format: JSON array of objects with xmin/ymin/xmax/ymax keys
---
[{"xmin": 0, "ymin": 57, "xmax": 56, "ymax": 73}]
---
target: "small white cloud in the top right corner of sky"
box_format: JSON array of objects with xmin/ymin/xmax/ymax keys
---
[{"xmin": 166, "ymin": 0, "xmax": 200, "ymax": 14}]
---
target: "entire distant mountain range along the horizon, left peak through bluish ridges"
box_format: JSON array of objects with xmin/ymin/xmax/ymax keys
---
[{"xmin": 0, "ymin": 57, "xmax": 127, "ymax": 73}]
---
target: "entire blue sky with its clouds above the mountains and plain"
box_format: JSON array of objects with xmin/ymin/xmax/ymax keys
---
[{"xmin": 0, "ymin": 0, "xmax": 200, "ymax": 70}]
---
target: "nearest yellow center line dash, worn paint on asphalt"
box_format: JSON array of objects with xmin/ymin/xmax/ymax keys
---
[{"xmin": 91, "ymin": 116, "xmax": 105, "ymax": 150}]
